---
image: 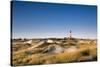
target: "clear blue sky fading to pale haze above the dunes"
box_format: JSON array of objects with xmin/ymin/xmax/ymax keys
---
[{"xmin": 12, "ymin": 1, "xmax": 97, "ymax": 38}]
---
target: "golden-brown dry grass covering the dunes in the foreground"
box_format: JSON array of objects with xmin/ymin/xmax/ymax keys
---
[{"xmin": 12, "ymin": 40, "xmax": 97, "ymax": 66}]
